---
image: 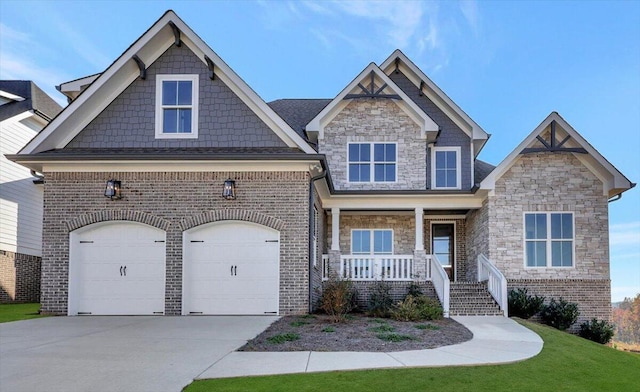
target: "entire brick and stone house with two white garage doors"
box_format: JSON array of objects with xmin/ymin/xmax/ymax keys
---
[{"xmin": 10, "ymin": 11, "xmax": 633, "ymax": 319}]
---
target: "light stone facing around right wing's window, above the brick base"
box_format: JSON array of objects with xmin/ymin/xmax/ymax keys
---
[{"xmin": 488, "ymin": 153, "xmax": 609, "ymax": 279}]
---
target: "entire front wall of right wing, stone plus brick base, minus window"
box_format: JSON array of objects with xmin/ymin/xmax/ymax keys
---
[{"xmin": 467, "ymin": 152, "xmax": 611, "ymax": 324}]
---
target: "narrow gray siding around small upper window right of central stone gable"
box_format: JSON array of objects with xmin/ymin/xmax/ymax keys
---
[{"xmin": 389, "ymin": 72, "xmax": 473, "ymax": 190}]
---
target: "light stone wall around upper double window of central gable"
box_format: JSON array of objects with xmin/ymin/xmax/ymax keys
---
[{"xmin": 318, "ymin": 99, "xmax": 427, "ymax": 190}]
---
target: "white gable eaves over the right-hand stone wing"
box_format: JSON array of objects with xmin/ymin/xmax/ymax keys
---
[{"xmin": 480, "ymin": 112, "xmax": 635, "ymax": 198}]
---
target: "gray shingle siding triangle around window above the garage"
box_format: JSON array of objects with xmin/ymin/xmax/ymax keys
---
[{"xmin": 66, "ymin": 45, "xmax": 286, "ymax": 148}]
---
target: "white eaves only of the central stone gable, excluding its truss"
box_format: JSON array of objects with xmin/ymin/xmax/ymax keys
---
[{"xmin": 306, "ymin": 63, "xmax": 439, "ymax": 138}]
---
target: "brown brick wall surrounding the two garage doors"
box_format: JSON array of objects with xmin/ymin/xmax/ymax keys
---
[{"xmin": 42, "ymin": 172, "xmax": 309, "ymax": 315}]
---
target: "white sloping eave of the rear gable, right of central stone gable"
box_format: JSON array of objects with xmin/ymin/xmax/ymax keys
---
[{"xmin": 380, "ymin": 49, "xmax": 490, "ymax": 156}]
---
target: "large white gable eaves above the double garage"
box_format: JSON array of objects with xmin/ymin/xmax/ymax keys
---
[{"xmin": 19, "ymin": 10, "xmax": 315, "ymax": 154}]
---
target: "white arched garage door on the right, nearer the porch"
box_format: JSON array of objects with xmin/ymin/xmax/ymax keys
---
[{"xmin": 182, "ymin": 221, "xmax": 280, "ymax": 315}]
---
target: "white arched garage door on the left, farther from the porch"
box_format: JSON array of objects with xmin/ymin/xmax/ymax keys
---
[{"xmin": 69, "ymin": 221, "xmax": 165, "ymax": 315}]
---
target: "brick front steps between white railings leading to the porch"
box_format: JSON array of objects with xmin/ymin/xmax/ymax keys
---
[{"xmin": 449, "ymin": 282, "xmax": 504, "ymax": 316}]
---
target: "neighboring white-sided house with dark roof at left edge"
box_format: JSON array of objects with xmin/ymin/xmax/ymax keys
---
[{"xmin": 0, "ymin": 80, "xmax": 62, "ymax": 302}]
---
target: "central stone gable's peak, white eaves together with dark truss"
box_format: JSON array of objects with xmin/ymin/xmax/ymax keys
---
[{"xmin": 306, "ymin": 63, "xmax": 439, "ymax": 142}]
